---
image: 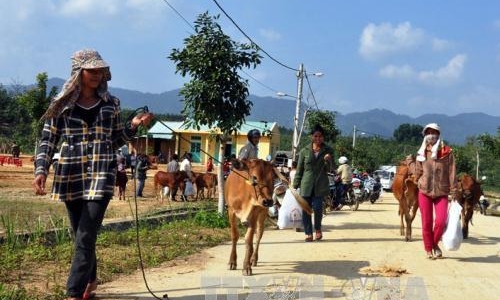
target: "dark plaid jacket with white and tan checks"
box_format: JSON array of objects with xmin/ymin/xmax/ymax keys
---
[{"xmin": 35, "ymin": 97, "xmax": 135, "ymax": 201}]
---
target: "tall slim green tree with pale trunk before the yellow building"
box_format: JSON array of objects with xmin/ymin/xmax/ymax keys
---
[{"xmin": 169, "ymin": 12, "xmax": 261, "ymax": 213}]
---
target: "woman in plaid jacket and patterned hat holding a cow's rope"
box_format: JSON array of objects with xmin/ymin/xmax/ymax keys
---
[{"xmin": 33, "ymin": 49, "xmax": 153, "ymax": 300}]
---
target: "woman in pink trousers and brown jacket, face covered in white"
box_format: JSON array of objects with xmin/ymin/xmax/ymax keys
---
[{"xmin": 416, "ymin": 123, "xmax": 457, "ymax": 259}]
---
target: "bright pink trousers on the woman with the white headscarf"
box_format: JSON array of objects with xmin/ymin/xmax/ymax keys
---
[{"xmin": 418, "ymin": 191, "xmax": 448, "ymax": 251}]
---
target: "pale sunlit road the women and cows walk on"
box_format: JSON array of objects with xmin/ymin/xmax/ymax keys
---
[{"xmin": 98, "ymin": 194, "xmax": 500, "ymax": 300}]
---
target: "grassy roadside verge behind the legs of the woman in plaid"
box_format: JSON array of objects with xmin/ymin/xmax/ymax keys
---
[{"xmin": 0, "ymin": 203, "xmax": 230, "ymax": 300}]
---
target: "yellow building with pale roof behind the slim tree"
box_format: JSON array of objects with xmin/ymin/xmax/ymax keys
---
[{"xmin": 135, "ymin": 121, "xmax": 280, "ymax": 164}]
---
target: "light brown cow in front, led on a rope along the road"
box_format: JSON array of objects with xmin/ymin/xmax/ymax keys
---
[{"xmin": 224, "ymin": 159, "xmax": 274, "ymax": 276}]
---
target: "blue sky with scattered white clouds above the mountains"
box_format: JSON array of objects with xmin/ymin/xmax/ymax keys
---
[{"xmin": 0, "ymin": 0, "xmax": 500, "ymax": 117}]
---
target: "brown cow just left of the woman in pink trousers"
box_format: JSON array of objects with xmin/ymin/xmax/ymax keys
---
[{"xmin": 392, "ymin": 155, "xmax": 418, "ymax": 242}]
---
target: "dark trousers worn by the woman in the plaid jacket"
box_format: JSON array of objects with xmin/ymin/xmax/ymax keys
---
[{"xmin": 64, "ymin": 198, "xmax": 110, "ymax": 298}]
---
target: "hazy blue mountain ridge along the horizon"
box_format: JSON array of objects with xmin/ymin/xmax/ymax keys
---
[{"xmin": 41, "ymin": 78, "xmax": 500, "ymax": 145}]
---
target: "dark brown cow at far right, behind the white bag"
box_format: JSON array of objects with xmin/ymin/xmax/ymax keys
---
[{"xmin": 457, "ymin": 174, "xmax": 482, "ymax": 239}]
